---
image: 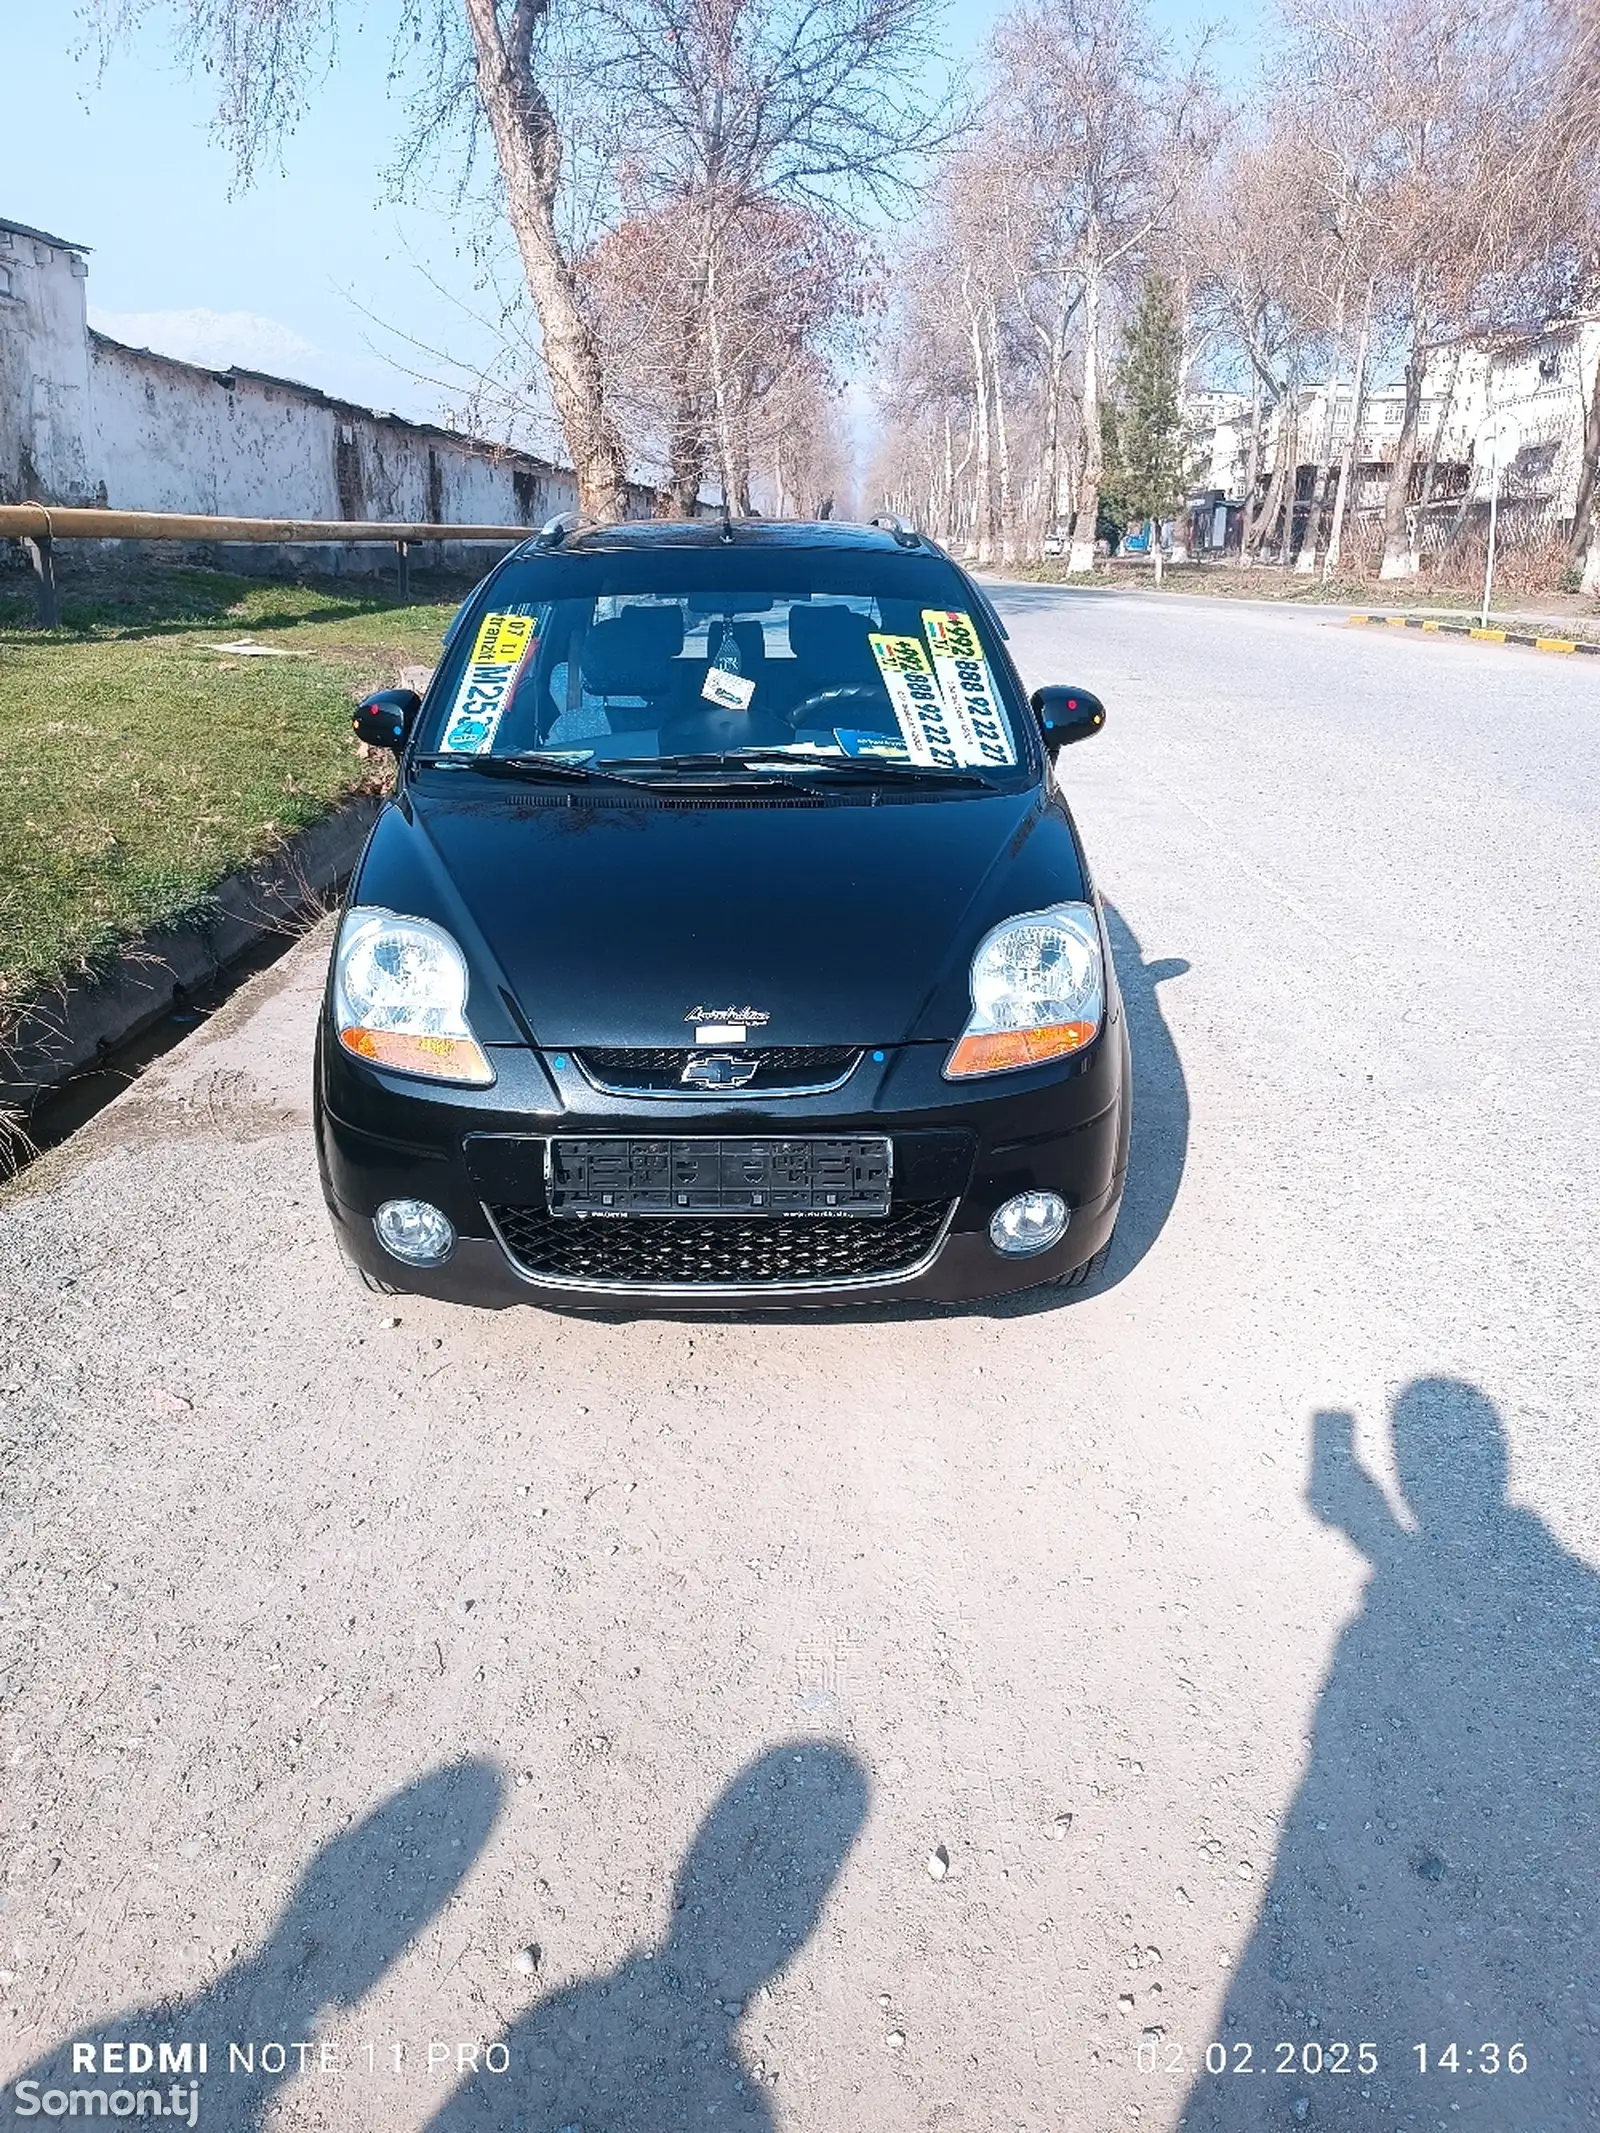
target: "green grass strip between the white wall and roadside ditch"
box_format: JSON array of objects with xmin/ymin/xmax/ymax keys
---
[{"xmin": 0, "ymin": 567, "xmax": 463, "ymax": 1030}]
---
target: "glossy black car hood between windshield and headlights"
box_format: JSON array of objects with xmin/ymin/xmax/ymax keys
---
[{"xmin": 354, "ymin": 774, "xmax": 1088, "ymax": 1047}]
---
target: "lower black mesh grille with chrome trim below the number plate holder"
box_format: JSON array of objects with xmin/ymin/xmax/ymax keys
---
[{"xmin": 489, "ymin": 1201, "xmax": 949, "ymax": 1288}]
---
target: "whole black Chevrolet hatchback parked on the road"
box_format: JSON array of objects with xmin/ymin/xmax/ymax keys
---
[{"xmin": 316, "ymin": 520, "xmax": 1129, "ymax": 1310}]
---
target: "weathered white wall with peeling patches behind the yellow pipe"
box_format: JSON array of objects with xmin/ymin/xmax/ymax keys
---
[{"xmin": 0, "ymin": 209, "xmax": 655, "ymax": 570}]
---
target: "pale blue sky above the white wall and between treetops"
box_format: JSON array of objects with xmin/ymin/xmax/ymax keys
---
[{"xmin": 0, "ymin": 0, "xmax": 1265, "ymax": 441}]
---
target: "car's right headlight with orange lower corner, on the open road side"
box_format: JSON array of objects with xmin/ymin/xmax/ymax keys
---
[{"xmin": 945, "ymin": 904, "xmax": 1105, "ymax": 1081}]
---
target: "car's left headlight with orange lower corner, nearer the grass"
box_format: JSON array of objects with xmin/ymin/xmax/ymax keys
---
[{"xmin": 333, "ymin": 909, "xmax": 495, "ymax": 1088}]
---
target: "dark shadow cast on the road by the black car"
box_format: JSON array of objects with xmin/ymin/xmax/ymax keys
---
[{"xmin": 588, "ymin": 904, "xmax": 1188, "ymax": 1325}]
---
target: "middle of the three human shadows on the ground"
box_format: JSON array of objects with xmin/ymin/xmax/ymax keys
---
[{"xmin": 429, "ymin": 1741, "xmax": 868, "ymax": 2133}]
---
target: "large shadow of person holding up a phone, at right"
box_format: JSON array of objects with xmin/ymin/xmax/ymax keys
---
[{"xmin": 1180, "ymin": 1378, "xmax": 1600, "ymax": 2133}]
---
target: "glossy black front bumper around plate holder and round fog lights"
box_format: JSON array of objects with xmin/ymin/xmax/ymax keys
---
[{"xmin": 316, "ymin": 1019, "xmax": 1129, "ymax": 1314}]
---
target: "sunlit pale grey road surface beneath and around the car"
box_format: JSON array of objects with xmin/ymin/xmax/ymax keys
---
[{"xmin": 0, "ymin": 589, "xmax": 1600, "ymax": 2133}]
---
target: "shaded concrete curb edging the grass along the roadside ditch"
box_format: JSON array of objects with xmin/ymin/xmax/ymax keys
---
[{"xmin": 0, "ymin": 793, "xmax": 384, "ymax": 1111}]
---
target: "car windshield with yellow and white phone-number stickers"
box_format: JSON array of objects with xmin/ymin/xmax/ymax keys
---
[{"xmin": 416, "ymin": 544, "xmax": 1030, "ymax": 789}]
